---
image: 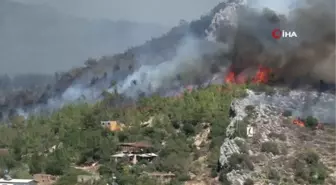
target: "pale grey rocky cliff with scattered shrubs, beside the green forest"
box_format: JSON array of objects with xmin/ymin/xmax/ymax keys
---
[{"xmin": 219, "ymin": 89, "xmax": 336, "ymax": 185}]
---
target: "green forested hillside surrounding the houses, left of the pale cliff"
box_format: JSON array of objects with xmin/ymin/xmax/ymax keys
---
[{"xmin": 0, "ymin": 86, "xmax": 244, "ymax": 185}]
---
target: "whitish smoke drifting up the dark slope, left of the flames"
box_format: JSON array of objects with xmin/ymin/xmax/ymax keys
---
[{"xmin": 113, "ymin": 36, "xmax": 228, "ymax": 97}]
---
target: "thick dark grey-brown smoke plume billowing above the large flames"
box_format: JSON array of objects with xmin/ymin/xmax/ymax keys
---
[{"xmin": 216, "ymin": 0, "xmax": 336, "ymax": 83}]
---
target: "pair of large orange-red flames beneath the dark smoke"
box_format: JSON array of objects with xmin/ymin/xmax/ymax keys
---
[{"xmin": 225, "ymin": 65, "xmax": 272, "ymax": 84}]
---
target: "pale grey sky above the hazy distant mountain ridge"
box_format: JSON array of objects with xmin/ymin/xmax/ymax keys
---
[{"xmin": 13, "ymin": 0, "xmax": 226, "ymax": 26}]
